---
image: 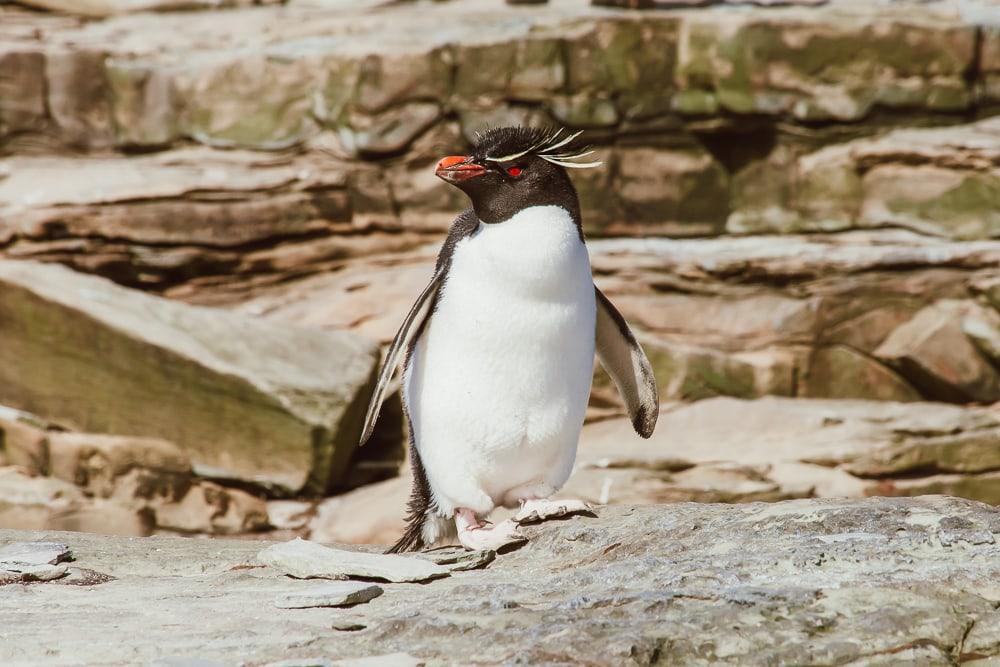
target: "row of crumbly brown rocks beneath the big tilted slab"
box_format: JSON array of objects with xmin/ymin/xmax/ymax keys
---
[{"xmin": 0, "ymin": 407, "xmax": 271, "ymax": 536}]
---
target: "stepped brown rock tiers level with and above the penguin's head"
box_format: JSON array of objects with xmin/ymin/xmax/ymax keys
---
[{"xmin": 0, "ymin": 0, "xmax": 997, "ymax": 272}]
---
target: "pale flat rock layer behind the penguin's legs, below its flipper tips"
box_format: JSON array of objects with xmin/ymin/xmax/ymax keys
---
[{"xmin": 308, "ymin": 397, "xmax": 1000, "ymax": 544}]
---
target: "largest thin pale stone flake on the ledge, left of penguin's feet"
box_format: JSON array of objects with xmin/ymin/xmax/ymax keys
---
[{"xmin": 258, "ymin": 538, "xmax": 448, "ymax": 582}]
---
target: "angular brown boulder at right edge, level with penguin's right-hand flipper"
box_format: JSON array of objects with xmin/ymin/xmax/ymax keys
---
[{"xmin": 875, "ymin": 301, "xmax": 1000, "ymax": 402}]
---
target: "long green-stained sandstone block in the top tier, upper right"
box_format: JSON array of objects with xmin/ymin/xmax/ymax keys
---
[{"xmin": 677, "ymin": 13, "xmax": 975, "ymax": 121}]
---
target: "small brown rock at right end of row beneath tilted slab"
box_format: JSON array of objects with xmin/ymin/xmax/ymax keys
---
[{"xmin": 155, "ymin": 481, "xmax": 269, "ymax": 535}]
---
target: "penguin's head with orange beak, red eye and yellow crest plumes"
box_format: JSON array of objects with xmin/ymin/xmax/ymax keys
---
[{"xmin": 434, "ymin": 127, "xmax": 601, "ymax": 224}]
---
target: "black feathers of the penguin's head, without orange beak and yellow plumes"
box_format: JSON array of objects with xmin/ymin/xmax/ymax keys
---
[{"xmin": 446, "ymin": 127, "xmax": 583, "ymax": 234}]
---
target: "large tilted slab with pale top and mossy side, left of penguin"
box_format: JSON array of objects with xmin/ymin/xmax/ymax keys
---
[{"xmin": 0, "ymin": 262, "xmax": 376, "ymax": 496}]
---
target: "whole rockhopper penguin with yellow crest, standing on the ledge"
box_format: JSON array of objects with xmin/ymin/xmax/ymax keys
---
[{"xmin": 361, "ymin": 127, "xmax": 659, "ymax": 553}]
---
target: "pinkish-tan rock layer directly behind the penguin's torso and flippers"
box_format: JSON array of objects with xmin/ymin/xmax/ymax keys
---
[{"xmin": 229, "ymin": 231, "xmax": 1000, "ymax": 407}]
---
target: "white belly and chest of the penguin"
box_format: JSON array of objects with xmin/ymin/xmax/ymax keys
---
[{"xmin": 404, "ymin": 206, "xmax": 596, "ymax": 515}]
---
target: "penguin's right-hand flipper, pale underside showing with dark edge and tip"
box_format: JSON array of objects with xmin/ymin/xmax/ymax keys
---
[{"xmin": 594, "ymin": 285, "xmax": 660, "ymax": 438}]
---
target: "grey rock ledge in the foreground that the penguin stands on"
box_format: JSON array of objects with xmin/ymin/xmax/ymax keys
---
[{"xmin": 0, "ymin": 496, "xmax": 1000, "ymax": 665}]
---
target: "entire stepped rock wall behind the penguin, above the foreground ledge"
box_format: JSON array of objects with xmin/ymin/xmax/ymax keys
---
[{"xmin": 0, "ymin": 0, "xmax": 1000, "ymax": 543}]
